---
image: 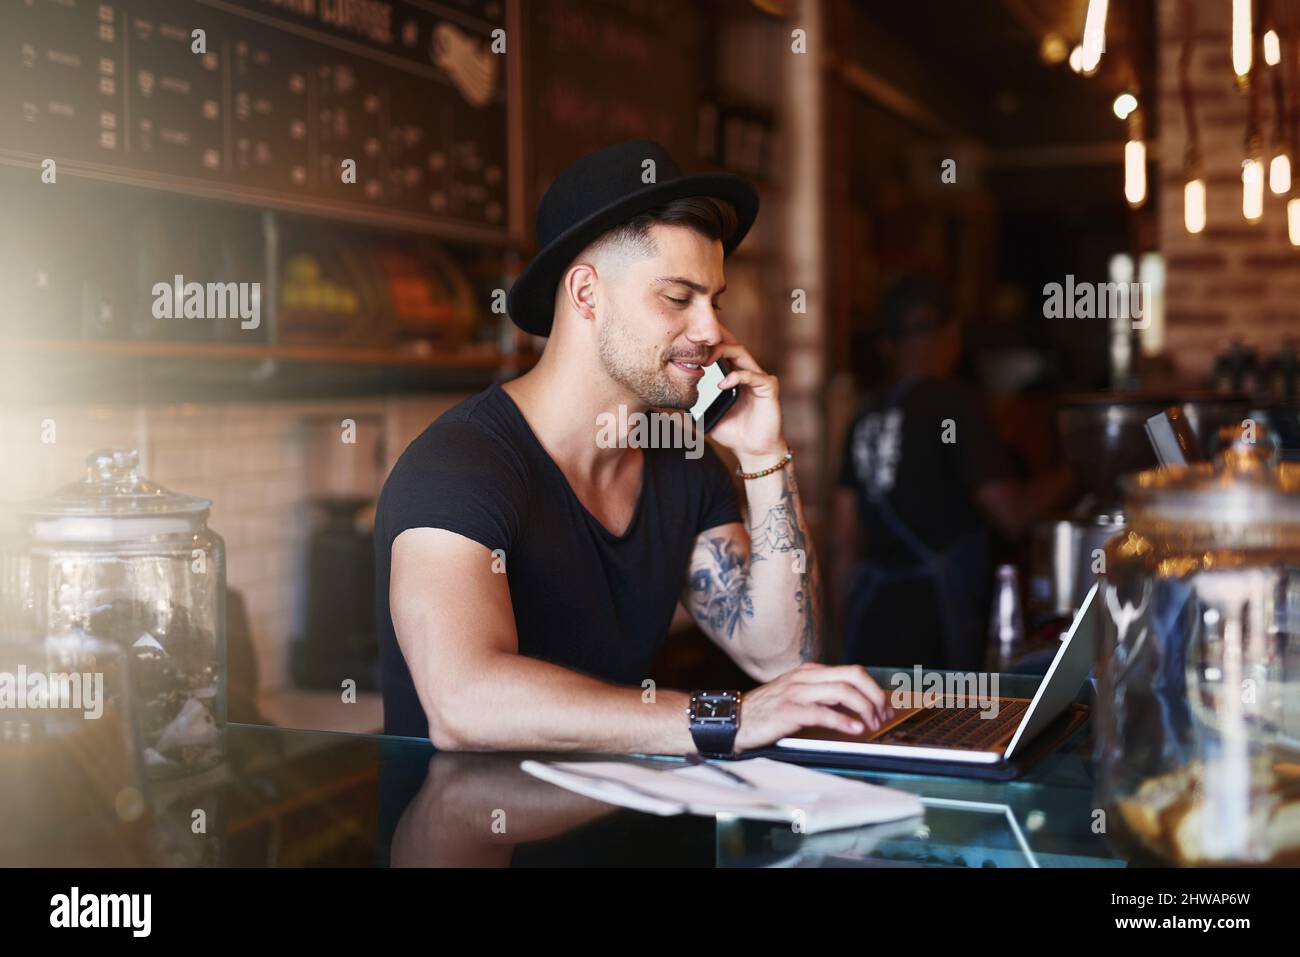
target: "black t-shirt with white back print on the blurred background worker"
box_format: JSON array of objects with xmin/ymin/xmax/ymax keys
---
[{"xmin": 839, "ymin": 378, "xmax": 1014, "ymax": 567}]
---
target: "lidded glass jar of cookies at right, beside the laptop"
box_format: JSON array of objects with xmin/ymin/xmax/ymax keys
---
[{"xmin": 1096, "ymin": 423, "xmax": 1300, "ymax": 865}]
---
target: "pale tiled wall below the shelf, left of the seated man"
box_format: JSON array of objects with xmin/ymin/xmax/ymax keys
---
[{"xmin": 0, "ymin": 395, "xmax": 462, "ymax": 690}]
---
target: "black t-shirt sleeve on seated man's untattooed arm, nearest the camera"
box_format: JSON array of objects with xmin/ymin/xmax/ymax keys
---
[{"xmin": 376, "ymin": 421, "xmax": 528, "ymax": 554}]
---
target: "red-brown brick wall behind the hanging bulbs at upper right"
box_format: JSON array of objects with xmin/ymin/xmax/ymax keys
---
[{"xmin": 1153, "ymin": 0, "xmax": 1300, "ymax": 378}]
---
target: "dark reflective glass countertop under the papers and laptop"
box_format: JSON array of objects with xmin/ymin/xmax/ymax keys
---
[{"xmin": 0, "ymin": 676, "xmax": 1125, "ymax": 867}]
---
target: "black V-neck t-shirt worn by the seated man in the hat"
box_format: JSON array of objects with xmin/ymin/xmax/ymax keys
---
[{"xmin": 374, "ymin": 385, "xmax": 741, "ymax": 737}]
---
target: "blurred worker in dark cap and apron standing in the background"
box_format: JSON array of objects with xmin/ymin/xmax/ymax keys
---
[{"xmin": 832, "ymin": 280, "xmax": 1075, "ymax": 671}]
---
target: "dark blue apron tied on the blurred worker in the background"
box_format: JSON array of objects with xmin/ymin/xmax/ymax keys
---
[{"xmin": 844, "ymin": 381, "xmax": 991, "ymax": 671}]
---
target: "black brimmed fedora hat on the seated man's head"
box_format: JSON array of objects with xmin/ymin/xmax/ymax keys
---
[{"xmin": 506, "ymin": 139, "xmax": 758, "ymax": 335}]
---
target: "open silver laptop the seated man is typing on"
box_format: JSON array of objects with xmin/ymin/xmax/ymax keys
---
[{"xmin": 771, "ymin": 584, "xmax": 1100, "ymax": 766}]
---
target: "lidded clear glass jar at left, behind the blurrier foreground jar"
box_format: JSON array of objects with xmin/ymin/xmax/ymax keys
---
[{"xmin": 7, "ymin": 449, "xmax": 226, "ymax": 779}]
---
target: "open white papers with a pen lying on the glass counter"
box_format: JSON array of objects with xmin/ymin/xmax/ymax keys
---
[{"xmin": 520, "ymin": 758, "xmax": 924, "ymax": 833}]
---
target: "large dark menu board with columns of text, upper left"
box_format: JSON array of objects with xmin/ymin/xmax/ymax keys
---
[{"xmin": 0, "ymin": 0, "xmax": 517, "ymax": 242}]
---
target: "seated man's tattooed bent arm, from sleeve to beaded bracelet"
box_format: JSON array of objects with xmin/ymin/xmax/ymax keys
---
[{"xmin": 683, "ymin": 463, "xmax": 823, "ymax": 681}]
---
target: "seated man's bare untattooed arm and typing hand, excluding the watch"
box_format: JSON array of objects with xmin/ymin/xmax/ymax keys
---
[{"xmin": 389, "ymin": 528, "xmax": 889, "ymax": 754}]
